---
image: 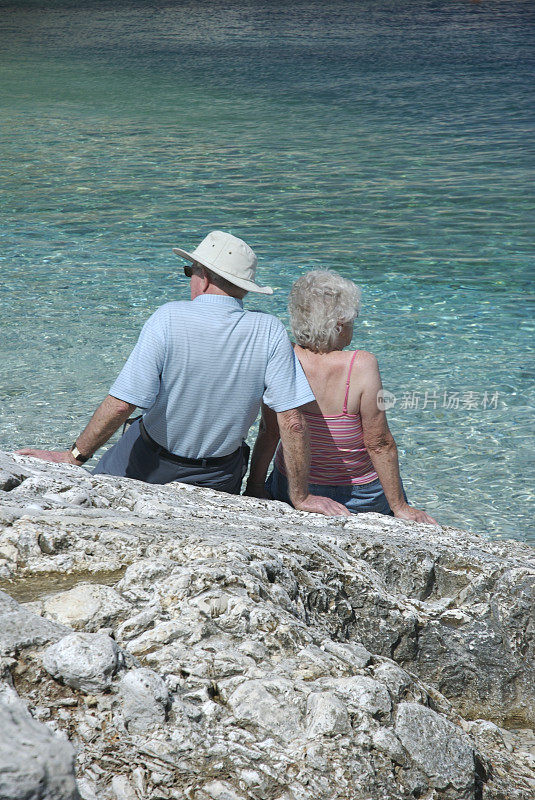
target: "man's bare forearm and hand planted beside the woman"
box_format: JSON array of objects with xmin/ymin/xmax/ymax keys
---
[{"xmin": 277, "ymin": 408, "xmax": 350, "ymax": 516}]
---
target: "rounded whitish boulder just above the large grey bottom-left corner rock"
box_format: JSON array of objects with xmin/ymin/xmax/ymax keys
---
[{"xmin": 43, "ymin": 633, "xmax": 122, "ymax": 692}]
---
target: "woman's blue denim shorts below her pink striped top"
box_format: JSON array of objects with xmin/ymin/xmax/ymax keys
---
[{"xmin": 266, "ymin": 467, "xmax": 407, "ymax": 517}]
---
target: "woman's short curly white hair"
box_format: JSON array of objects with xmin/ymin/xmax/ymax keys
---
[{"xmin": 288, "ymin": 269, "xmax": 361, "ymax": 353}]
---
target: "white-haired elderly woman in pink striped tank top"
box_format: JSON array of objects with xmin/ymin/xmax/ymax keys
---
[{"xmin": 245, "ymin": 270, "xmax": 436, "ymax": 524}]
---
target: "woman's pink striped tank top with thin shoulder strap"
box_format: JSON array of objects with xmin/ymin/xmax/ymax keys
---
[{"xmin": 275, "ymin": 350, "xmax": 377, "ymax": 486}]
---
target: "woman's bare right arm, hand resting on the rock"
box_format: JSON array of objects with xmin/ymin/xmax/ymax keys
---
[{"xmin": 360, "ymin": 353, "xmax": 438, "ymax": 525}]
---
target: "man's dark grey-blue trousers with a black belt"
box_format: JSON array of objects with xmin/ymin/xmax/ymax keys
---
[{"xmin": 93, "ymin": 420, "xmax": 247, "ymax": 494}]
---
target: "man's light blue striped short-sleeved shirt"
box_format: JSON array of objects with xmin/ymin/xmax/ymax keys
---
[{"xmin": 110, "ymin": 294, "xmax": 314, "ymax": 458}]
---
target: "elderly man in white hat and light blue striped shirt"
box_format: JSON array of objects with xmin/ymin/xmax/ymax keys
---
[{"xmin": 18, "ymin": 231, "xmax": 348, "ymax": 514}]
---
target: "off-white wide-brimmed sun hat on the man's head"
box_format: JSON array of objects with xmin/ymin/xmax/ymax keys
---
[{"xmin": 173, "ymin": 231, "xmax": 273, "ymax": 294}]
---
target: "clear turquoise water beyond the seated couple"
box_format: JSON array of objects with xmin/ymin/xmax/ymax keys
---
[{"xmin": 0, "ymin": 0, "xmax": 535, "ymax": 542}]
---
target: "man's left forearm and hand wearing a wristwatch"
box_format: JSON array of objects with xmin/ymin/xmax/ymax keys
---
[{"xmin": 16, "ymin": 395, "xmax": 136, "ymax": 466}]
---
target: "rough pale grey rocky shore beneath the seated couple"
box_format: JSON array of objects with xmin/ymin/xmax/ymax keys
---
[{"xmin": 0, "ymin": 453, "xmax": 535, "ymax": 800}]
